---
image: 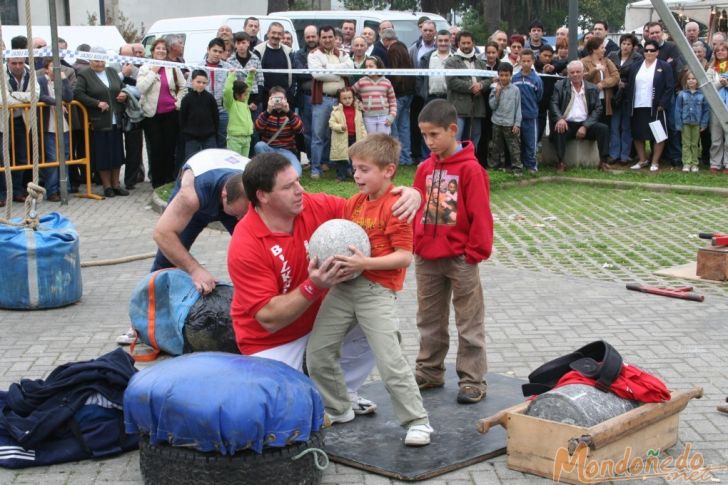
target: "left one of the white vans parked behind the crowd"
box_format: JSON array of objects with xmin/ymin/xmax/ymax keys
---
[{"xmin": 142, "ymin": 15, "xmax": 299, "ymax": 64}]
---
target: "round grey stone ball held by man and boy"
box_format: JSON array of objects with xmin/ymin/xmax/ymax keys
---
[{"xmin": 308, "ymin": 219, "xmax": 371, "ymax": 279}]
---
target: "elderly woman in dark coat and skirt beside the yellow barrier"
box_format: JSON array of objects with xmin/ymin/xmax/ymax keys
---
[{"xmin": 73, "ymin": 47, "xmax": 129, "ymax": 197}]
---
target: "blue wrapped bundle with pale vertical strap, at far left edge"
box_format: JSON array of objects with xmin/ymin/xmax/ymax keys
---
[{"xmin": 0, "ymin": 212, "xmax": 83, "ymax": 310}]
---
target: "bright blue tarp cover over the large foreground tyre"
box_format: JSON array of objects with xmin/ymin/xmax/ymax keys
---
[{"xmin": 124, "ymin": 352, "xmax": 324, "ymax": 455}]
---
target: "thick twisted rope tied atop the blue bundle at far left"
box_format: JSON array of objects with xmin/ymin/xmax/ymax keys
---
[{"xmin": 23, "ymin": 0, "xmax": 45, "ymax": 229}]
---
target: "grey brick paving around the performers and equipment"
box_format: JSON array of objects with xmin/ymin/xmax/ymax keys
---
[{"xmin": 0, "ymin": 184, "xmax": 728, "ymax": 485}]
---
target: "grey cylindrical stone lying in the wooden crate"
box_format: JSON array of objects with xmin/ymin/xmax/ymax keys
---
[{"xmin": 526, "ymin": 384, "xmax": 640, "ymax": 427}]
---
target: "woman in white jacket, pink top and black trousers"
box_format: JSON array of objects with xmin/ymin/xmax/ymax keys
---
[{"xmin": 137, "ymin": 39, "xmax": 187, "ymax": 187}]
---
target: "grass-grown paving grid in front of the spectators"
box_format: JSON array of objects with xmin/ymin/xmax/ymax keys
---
[{"xmin": 157, "ymin": 167, "xmax": 728, "ymax": 296}]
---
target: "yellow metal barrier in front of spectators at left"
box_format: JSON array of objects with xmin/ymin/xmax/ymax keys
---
[{"xmin": 0, "ymin": 101, "xmax": 103, "ymax": 200}]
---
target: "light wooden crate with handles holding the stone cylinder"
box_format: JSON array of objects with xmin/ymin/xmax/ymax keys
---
[{"xmin": 478, "ymin": 388, "xmax": 703, "ymax": 484}]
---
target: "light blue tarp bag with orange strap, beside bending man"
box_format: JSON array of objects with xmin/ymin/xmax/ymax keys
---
[{"xmin": 129, "ymin": 268, "xmax": 200, "ymax": 361}]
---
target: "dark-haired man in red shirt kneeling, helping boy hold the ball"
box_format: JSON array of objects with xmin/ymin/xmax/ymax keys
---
[{"xmin": 228, "ymin": 153, "xmax": 421, "ymax": 413}]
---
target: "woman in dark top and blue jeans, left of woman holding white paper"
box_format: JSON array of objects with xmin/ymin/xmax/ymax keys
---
[{"xmin": 607, "ymin": 34, "xmax": 643, "ymax": 164}]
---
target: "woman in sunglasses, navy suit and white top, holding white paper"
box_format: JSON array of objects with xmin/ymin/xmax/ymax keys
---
[{"xmin": 625, "ymin": 40, "xmax": 675, "ymax": 172}]
